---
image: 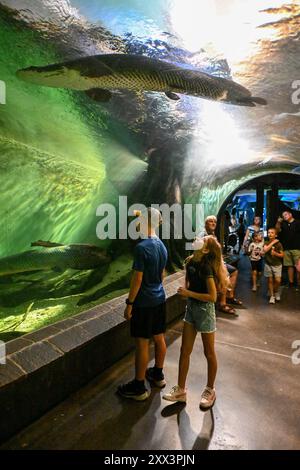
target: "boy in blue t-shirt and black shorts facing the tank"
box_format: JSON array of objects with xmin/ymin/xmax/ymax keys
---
[{"xmin": 118, "ymin": 208, "xmax": 168, "ymax": 401}]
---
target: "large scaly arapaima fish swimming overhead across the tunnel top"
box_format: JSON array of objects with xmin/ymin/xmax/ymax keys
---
[{"xmin": 17, "ymin": 54, "xmax": 267, "ymax": 106}]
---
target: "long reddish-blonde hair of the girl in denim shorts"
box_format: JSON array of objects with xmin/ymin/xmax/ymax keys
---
[{"xmin": 186, "ymin": 235, "xmax": 228, "ymax": 291}]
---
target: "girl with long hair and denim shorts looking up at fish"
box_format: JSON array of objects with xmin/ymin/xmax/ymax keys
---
[{"xmin": 163, "ymin": 235, "xmax": 227, "ymax": 410}]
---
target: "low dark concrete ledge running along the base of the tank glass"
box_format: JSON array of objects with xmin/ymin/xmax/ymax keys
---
[{"xmin": 0, "ymin": 272, "xmax": 185, "ymax": 441}]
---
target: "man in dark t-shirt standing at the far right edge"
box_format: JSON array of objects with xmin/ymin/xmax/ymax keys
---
[{"xmin": 279, "ymin": 210, "xmax": 300, "ymax": 289}]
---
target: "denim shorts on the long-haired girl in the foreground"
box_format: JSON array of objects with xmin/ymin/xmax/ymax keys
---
[{"xmin": 184, "ymin": 299, "xmax": 217, "ymax": 333}]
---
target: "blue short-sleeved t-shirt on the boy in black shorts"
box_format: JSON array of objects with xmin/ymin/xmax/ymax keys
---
[{"xmin": 132, "ymin": 237, "xmax": 168, "ymax": 307}]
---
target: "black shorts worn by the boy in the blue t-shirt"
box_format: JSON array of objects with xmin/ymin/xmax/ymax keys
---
[{"xmin": 130, "ymin": 302, "xmax": 166, "ymax": 339}]
